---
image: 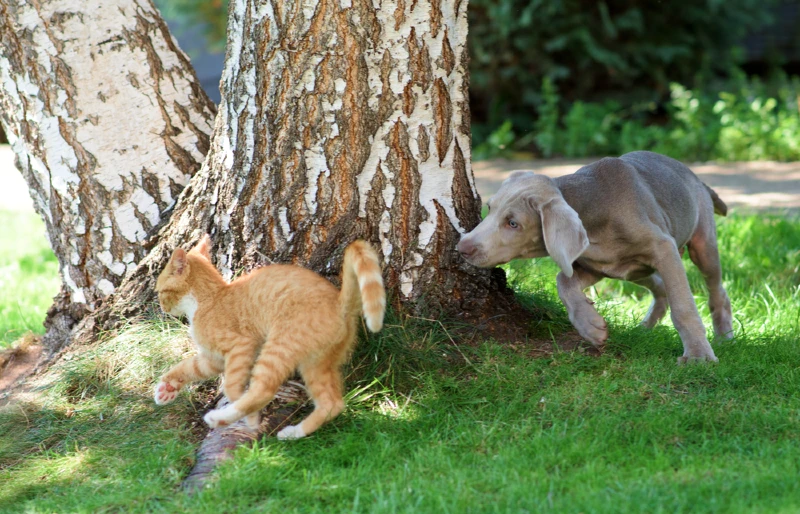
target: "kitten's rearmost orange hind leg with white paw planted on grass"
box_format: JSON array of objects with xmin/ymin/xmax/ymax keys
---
[{"xmin": 278, "ymin": 359, "xmax": 344, "ymax": 440}]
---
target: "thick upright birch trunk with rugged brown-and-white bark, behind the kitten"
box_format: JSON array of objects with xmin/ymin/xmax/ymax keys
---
[{"xmin": 97, "ymin": 0, "xmax": 498, "ymax": 318}]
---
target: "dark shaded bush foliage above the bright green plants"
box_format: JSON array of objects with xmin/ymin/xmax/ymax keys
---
[{"xmin": 468, "ymin": 0, "xmax": 774, "ymax": 134}]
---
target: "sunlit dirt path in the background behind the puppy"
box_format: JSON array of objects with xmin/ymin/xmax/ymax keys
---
[{"xmin": 472, "ymin": 159, "xmax": 800, "ymax": 212}]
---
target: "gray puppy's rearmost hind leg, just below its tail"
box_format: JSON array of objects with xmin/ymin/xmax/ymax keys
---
[{"xmin": 688, "ymin": 209, "xmax": 733, "ymax": 339}]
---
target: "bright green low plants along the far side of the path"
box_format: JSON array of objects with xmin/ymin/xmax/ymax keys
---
[{"xmin": 476, "ymin": 76, "xmax": 800, "ymax": 161}]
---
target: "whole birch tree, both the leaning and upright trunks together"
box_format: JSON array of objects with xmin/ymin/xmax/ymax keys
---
[{"xmin": 0, "ymin": 0, "xmax": 502, "ymax": 348}]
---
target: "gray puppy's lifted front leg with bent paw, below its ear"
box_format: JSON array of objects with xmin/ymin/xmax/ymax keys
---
[{"xmin": 556, "ymin": 267, "xmax": 608, "ymax": 347}]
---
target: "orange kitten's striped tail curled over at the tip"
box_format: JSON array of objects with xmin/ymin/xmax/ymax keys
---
[{"xmin": 339, "ymin": 240, "xmax": 386, "ymax": 332}]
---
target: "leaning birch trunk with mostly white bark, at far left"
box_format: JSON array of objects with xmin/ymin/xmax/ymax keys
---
[{"xmin": 0, "ymin": 0, "xmax": 215, "ymax": 350}]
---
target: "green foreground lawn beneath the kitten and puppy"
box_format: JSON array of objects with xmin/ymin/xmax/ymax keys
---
[{"xmin": 0, "ymin": 211, "xmax": 800, "ymax": 513}]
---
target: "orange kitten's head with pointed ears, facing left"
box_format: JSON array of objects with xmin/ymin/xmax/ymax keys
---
[{"xmin": 156, "ymin": 234, "xmax": 211, "ymax": 316}]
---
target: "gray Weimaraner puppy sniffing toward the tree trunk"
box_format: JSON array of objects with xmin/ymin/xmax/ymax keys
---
[{"xmin": 458, "ymin": 152, "xmax": 733, "ymax": 363}]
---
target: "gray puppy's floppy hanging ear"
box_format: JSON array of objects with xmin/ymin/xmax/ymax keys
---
[{"xmin": 539, "ymin": 196, "xmax": 589, "ymax": 277}]
